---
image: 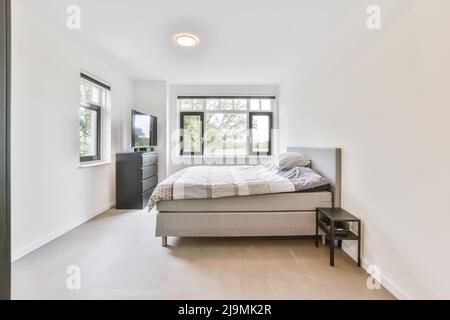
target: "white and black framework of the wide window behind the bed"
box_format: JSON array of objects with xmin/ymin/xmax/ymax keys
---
[{"xmin": 177, "ymin": 95, "xmax": 277, "ymax": 158}]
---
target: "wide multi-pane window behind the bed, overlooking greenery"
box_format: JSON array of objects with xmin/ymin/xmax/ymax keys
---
[{"xmin": 178, "ymin": 96, "xmax": 275, "ymax": 157}]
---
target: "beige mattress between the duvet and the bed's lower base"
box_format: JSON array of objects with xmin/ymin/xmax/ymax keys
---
[{"xmin": 156, "ymin": 191, "xmax": 333, "ymax": 213}]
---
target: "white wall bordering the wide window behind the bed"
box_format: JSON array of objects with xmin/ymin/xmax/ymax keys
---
[{"xmin": 167, "ymin": 85, "xmax": 278, "ymax": 174}]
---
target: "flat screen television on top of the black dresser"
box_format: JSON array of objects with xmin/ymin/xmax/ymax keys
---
[{"xmin": 131, "ymin": 110, "xmax": 158, "ymax": 149}]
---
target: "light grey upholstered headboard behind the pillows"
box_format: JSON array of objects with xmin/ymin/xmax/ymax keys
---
[{"xmin": 287, "ymin": 147, "xmax": 341, "ymax": 208}]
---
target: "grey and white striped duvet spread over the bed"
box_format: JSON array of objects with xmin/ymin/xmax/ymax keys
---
[{"xmin": 149, "ymin": 166, "xmax": 295, "ymax": 209}]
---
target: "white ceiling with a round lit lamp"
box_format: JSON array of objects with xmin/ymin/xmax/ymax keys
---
[{"xmin": 14, "ymin": 0, "xmax": 394, "ymax": 84}]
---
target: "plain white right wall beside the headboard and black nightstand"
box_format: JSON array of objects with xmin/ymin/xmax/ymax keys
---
[{"xmin": 280, "ymin": 0, "xmax": 450, "ymax": 299}]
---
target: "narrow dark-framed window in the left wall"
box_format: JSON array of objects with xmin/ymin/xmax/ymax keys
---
[{"xmin": 80, "ymin": 74, "xmax": 111, "ymax": 162}]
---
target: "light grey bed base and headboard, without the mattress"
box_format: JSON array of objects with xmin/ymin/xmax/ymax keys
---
[{"xmin": 156, "ymin": 147, "xmax": 341, "ymax": 247}]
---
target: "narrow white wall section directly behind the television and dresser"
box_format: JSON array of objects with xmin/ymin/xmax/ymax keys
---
[{"xmin": 134, "ymin": 81, "xmax": 168, "ymax": 181}]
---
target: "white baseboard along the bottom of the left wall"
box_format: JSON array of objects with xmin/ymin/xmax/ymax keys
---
[{"xmin": 11, "ymin": 201, "xmax": 116, "ymax": 262}]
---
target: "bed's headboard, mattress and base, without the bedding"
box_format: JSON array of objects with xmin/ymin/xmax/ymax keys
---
[{"xmin": 151, "ymin": 147, "xmax": 341, "ymax": 246}]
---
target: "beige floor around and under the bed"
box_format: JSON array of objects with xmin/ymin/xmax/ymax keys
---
[{"xmin": 12, "ymin": 209, "xmax": 394, "ymax": 299}]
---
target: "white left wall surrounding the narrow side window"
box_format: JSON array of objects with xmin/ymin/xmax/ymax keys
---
[{"xmin": 11, "ymin": 1, "xmax": 134, "ymax": 258}]
